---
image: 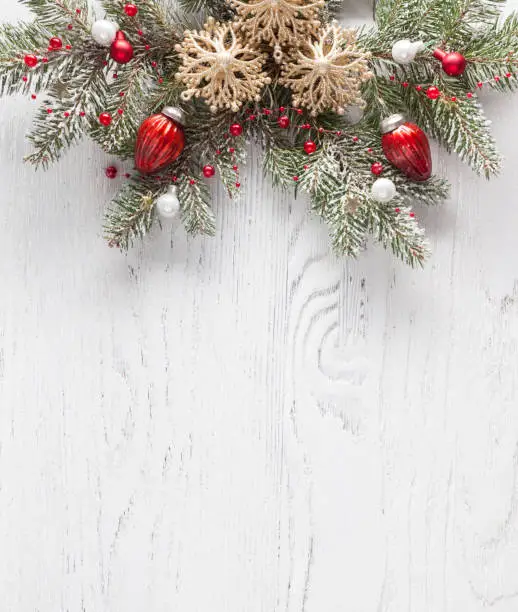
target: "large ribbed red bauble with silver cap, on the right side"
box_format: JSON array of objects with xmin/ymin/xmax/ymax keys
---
[{"xmin": 381, "ymin": 115, "xmax": 432, "ymax": 181}]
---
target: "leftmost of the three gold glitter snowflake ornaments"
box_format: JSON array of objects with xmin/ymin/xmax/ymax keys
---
[{"xmin": 175, "ymin": 18, "xmax": 271, "ymax": 112}]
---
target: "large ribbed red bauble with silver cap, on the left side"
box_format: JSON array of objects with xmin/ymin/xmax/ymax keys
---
[{"xmin": 135, "ymin": 106, "xmax": 185, "ymax": 174}]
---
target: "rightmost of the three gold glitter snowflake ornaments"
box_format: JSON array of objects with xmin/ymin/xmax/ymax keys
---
[{"xmin": 281, "ymin": 23, "xmax": 372, "ymax": 116}]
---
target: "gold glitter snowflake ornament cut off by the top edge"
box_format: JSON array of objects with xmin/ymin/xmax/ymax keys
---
[{"xmin": 229, "ymin": 0, "xmax": 324, "ymax": 47}]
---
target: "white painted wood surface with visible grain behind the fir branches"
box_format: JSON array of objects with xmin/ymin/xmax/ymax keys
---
[{"xmin": 0, "ymin": 0, "xmax": 518, "ymax": 612}]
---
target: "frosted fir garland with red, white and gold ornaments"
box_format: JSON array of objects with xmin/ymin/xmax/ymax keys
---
[{"xmin": 0, "ymin": 0, "xmax": 518, "ymax": 265}]
